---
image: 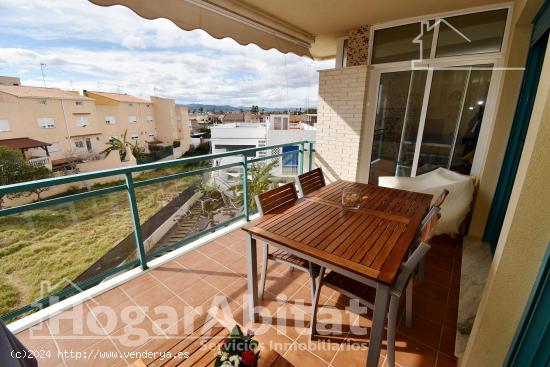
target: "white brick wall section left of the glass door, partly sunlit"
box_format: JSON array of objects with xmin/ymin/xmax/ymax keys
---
[{"xmin": 315, "ymin": 65, "xmax": 367, "ymax": 181}]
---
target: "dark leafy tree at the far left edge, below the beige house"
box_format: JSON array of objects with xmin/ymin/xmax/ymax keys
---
[{"xmin": 0, "ymin": 146, "xmax": 51, "ymax": 208}]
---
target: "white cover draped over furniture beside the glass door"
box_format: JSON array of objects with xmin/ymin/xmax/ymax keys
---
[{"xmin": 378, "ymin": 168, "xmax": 475, "ymax": 235}]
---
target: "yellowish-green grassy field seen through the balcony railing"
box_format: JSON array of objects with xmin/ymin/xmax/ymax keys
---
[{"xmin": 0, "ymin": 169, "xmax": 200, "ymax": 315}]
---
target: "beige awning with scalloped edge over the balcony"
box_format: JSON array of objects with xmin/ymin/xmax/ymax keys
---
[{"xmin": 89, "ymin": 0, "xmax": 315, "ymax": 57}]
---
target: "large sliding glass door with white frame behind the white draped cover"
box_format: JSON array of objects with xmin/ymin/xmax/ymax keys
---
[{"xmin": 369, "ymin": 65, "xmax": 492, "ymax": 184}]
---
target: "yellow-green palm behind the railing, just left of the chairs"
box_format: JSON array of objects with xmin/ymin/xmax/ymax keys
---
[{"xmin": 231, "ymin": 160, "xmax": 278, "ymax": 211}]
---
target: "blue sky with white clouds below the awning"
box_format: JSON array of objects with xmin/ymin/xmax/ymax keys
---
[{"xmin": 0, "ymin": 0, "xmax": 334, "ymax": 108}]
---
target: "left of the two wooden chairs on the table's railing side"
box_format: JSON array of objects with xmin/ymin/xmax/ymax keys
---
[{"xmin": 256, "ymin": 183, "xmax": 317, "ymax": 299}]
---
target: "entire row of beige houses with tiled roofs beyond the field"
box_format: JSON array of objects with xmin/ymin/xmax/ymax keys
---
[{"xmin": 0, "ymin": 85, "xmax": 190, "ymax": 169}]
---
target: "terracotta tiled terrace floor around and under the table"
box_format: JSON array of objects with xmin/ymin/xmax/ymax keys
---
[{"xmin": 17, "ymin": 230, "xmax": 461, "ymax": 367}]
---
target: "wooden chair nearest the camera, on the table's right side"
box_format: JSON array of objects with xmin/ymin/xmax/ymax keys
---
[{"xmin": 311, "ymin": 209, "xmax": 440, "ymax": 367}]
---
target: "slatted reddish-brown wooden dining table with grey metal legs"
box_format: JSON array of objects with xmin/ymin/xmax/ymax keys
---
[{"xmin": 243, "ymin": 180, "xmax": 432, "ymax": 367}]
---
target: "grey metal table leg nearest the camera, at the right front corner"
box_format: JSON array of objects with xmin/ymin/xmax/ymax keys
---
[{"xmin": 367, "ymin": 284, "xmax": 390, "ymax": 367}]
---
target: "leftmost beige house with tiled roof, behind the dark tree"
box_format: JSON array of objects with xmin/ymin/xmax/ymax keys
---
[{"xmin": 0, "ymin": 85, "xmax": 103, "ymax": 168}]
